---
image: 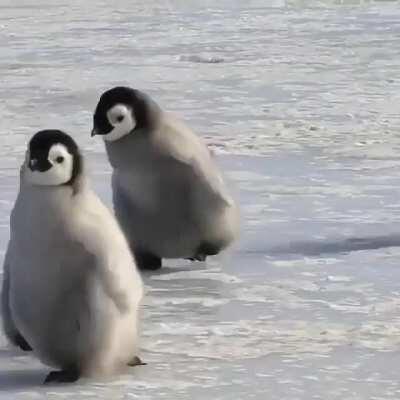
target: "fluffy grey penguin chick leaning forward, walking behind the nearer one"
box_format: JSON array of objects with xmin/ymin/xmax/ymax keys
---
[{"xmin": 92, "ymin": 87, "xmax": 239, "ymax": 269}]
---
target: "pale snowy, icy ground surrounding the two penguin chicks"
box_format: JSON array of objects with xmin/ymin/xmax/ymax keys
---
[{"xmin": 0, "ymin": 0, "xmax": 400, "ymax": 400}]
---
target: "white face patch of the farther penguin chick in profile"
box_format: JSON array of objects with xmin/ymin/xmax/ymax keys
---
[{"xmin": 103, "ymin": 104, "xmax": 136, "ymax": 142}]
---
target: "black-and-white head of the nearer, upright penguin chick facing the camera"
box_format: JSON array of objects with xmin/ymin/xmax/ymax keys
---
[{"xmin": 24, "ymin": 129, "xmax": 82, "ymax": 186}]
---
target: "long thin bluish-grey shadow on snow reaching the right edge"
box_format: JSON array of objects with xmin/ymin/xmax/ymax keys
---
[{"xmin": 266, "ymin": 234, "xmax": 400, "ymax": 257}]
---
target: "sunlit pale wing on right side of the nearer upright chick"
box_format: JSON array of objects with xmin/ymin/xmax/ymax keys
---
[{"xmin": 74, "ymin": 194, "xmax": 143, "ymax": 313}]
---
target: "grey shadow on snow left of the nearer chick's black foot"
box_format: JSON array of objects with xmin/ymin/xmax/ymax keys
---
[{"xmin": 0, "ymin": 349, "xmax": 46, "ymax": 392}]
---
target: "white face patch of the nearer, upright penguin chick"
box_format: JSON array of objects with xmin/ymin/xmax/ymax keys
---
[{"xmin": 24, "ymin": 143, "xmax": 74, "ymax": 186}]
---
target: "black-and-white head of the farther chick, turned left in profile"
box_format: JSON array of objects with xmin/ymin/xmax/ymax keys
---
[{"xmin": 92, "ymin": 86, "xmax": 157, "ymax": 142}]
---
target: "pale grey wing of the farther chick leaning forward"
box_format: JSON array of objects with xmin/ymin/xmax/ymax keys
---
[{"xmin": 157, "ymin": 114, "xmax": 232, "ymax": 206}]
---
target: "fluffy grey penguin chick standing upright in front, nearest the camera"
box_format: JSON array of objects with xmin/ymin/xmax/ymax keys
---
[{"xmin": 2, "ymin": 130, "xmax": 143, "ymax": 382}]
